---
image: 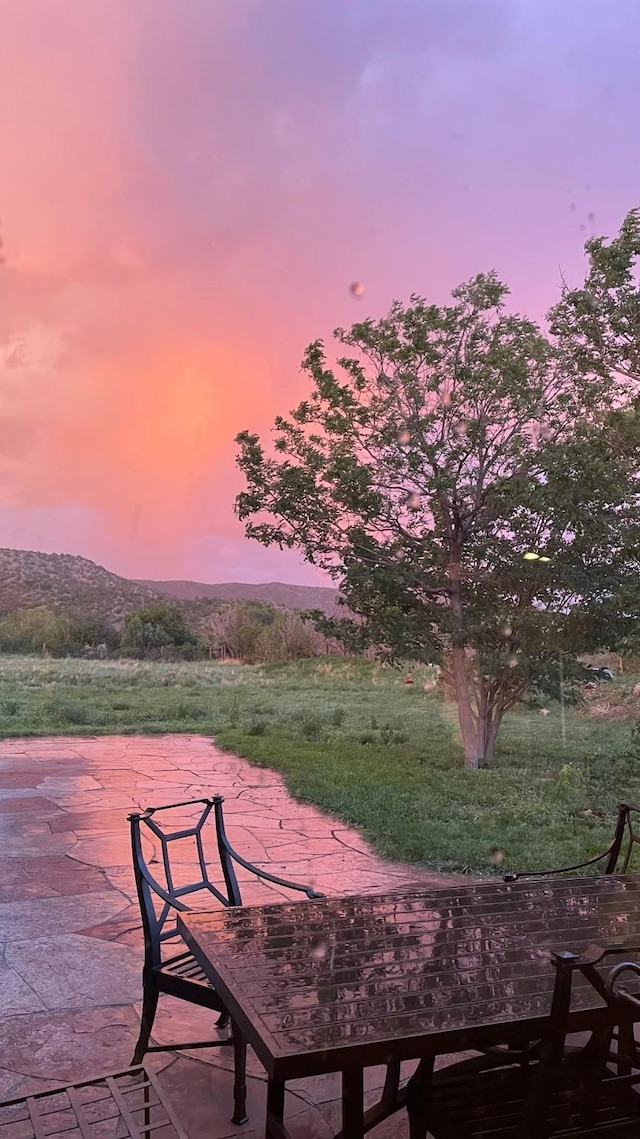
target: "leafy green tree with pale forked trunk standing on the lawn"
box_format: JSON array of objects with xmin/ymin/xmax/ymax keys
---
[{"xmin": 236, "ymin": 250, "xmax": 640, "ymax": 767}]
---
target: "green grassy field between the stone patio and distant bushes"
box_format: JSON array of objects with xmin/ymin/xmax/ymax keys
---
[{"xmin": 0, "ymin": 657, "xmax": 640, "ymax": 874}]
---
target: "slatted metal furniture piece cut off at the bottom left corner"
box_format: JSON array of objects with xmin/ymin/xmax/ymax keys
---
[{"xmin": 0, "ymin": 1067, "xmax": 187, "ymax": 1139}]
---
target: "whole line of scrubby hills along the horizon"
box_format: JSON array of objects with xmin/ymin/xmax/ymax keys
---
[{"xmin": 0, "ymin": 549, "xmax": 337, "ymax": 629}]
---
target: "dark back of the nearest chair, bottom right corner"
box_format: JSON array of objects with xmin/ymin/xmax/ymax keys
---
[{"xmin": 517, "ymin": 944, "xmax": 640, "ymax": 1139}]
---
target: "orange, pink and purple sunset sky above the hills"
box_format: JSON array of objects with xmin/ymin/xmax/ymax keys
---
[{"xmin": 0, "ymin": 0, "xmax": 640, "ymax": 583}]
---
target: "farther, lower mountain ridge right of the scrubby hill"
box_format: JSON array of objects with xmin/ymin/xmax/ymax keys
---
[{"xmin": 137, "ymin": 581, "xmax": 338, "ymax": 615}]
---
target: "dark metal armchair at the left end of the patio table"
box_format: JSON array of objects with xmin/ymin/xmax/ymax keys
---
[{"xmin": 128, "ymin": 795, "xmax": 323, "ymax": 1123}]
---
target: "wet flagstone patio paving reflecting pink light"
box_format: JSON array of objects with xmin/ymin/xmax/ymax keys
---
[{"xmin": 0, "ymin": 736, "xmax": 459, "ymax": 1139}]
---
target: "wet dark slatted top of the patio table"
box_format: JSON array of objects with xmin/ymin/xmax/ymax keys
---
[{"xmin": 179, "ymin": 875, "xmax": 640, "ymax": 1079}]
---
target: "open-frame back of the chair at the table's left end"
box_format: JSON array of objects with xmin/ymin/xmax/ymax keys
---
[{"xmin": 128, "ymin": 795, "xmax": 243, "ymax": 968}]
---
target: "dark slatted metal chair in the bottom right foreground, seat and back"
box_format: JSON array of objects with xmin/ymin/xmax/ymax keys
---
[{"xmin": 407, "ymin": 945, "xmax": 640, "ymax": 1139}]
